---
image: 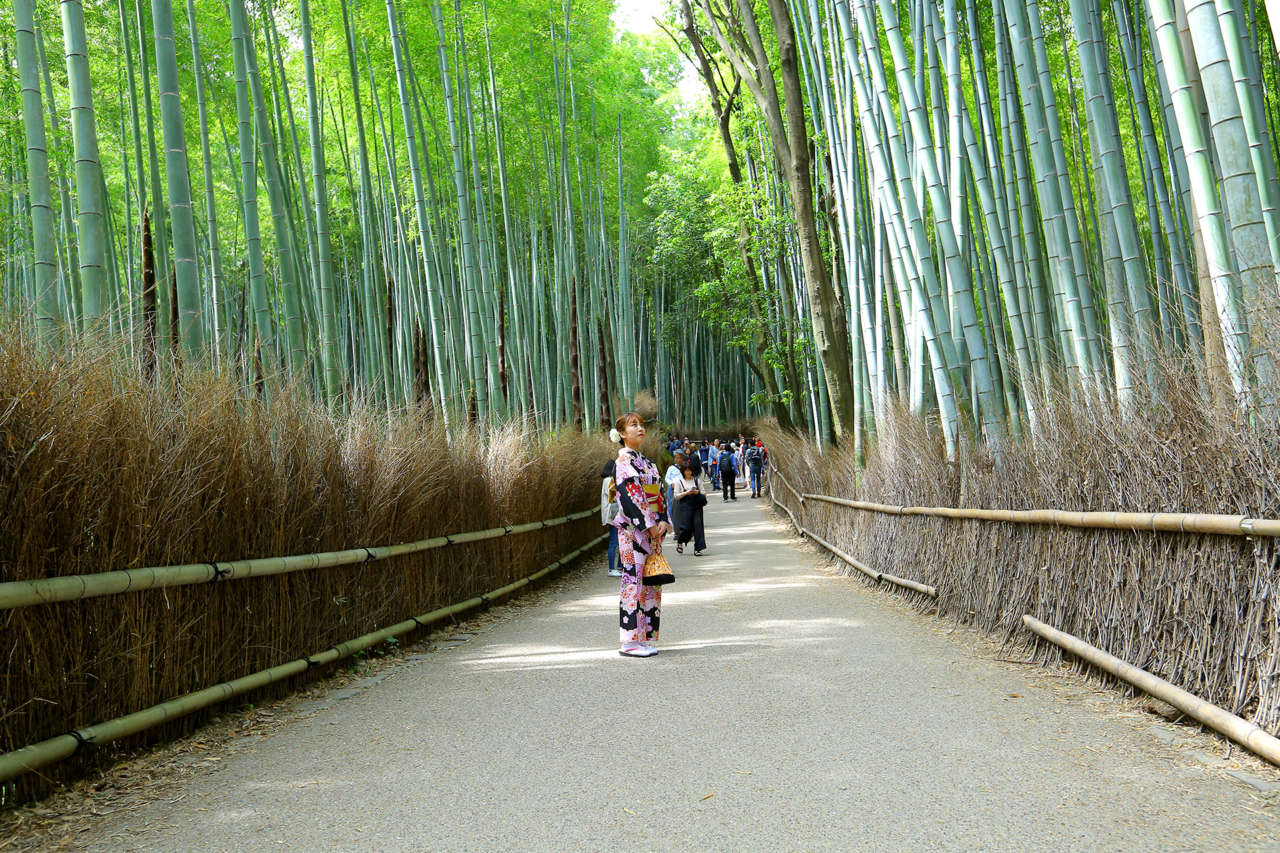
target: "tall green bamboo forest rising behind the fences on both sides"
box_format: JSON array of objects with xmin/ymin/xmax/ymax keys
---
[{"xmin": 0, "ymin": 0, "xmax": 1280, "ymax": 447}]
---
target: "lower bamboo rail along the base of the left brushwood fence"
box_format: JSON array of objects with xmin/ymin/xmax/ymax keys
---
[{"xmin": 0, "ymin": 532, "xmax": 605, "ymax": 781}]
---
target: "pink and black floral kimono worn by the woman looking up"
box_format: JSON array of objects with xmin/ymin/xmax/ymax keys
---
[{"xmin": 613, "ymin": 447, "xmax": 667, "ymax": 644}]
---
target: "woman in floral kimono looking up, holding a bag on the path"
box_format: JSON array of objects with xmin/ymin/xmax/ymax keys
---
[{"xmin": 611, "ymin": 411, "xmax": 671, "ymax": 657}]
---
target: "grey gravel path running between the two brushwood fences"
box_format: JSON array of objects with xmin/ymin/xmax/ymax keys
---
[{"xmin": 62, "ymin": 497, "xmax": 1280, "ymax": 853}]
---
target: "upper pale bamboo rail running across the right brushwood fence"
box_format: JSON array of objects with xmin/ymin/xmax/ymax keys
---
[{"xmin": 801, "ymin": 492, "xmax": 1280, "ymax": 537}]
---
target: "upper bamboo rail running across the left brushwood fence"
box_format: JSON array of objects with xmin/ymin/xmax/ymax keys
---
[{"xmin": 0, "ymin": 507, "xmax": 599, "ymax": 610}]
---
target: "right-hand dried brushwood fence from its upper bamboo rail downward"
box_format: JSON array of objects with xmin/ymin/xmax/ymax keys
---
[{"xmin": 769, "ymin": 458, "xmax": 1280, "ymax": 765}]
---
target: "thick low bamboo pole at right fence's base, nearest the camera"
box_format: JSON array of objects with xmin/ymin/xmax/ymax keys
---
[{"xmin": 1023, "ymin": 613, "xmax": 1280, "ymax": 765}]
